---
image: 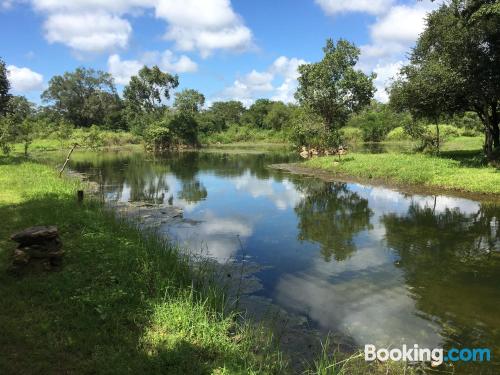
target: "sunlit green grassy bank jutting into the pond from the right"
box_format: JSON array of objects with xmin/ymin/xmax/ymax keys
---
[{"xmin": 301, "ymin": 152, "xmax": 500, "ymax": 194}]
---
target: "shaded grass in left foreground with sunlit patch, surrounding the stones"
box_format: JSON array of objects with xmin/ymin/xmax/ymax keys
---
[{"xmin": 0, "ymin": 195, "xmax": 278, "ymax": 374}]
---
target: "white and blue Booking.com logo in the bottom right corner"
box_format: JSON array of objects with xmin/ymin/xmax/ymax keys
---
[{"xmin": 365, "ymin": 344, "xmax": 491, "ymax": 366}]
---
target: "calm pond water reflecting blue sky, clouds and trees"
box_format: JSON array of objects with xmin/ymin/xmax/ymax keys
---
[{"xmin": 67, "ymin": 152, "xmax": 500, "ymax": 374}]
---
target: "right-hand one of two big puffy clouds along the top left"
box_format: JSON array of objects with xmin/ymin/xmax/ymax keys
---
[{"xmin": 156, "ymin": 0, "xmax": 252, "ymax": 57}]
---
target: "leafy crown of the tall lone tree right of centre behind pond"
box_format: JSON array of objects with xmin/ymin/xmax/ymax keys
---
[{"xmin": 295, "ymin": 39, "xmax": 375, "ymax": 132}]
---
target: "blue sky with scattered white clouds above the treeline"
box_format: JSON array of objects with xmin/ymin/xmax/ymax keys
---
[{"xmin": 0, "ymin": 0, "xmax": 437, "ymax": 106}]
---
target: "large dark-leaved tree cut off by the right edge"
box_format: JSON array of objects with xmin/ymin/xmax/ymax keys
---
[{"xmin": 391, "ymin": 0, "xmax": 500, "ymax": 159}]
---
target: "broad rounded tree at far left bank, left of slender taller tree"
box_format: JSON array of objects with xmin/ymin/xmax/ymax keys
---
[{"xmin": 42, "ymin": 67, "xmax": 121, "ymax": 127}]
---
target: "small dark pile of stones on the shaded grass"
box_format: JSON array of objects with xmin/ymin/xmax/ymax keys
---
[{"xmin": 10, "ymin": 226, "xmax": 64, "ymax": 269}]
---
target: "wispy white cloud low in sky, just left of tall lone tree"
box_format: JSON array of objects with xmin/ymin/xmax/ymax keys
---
[{"xmin": 219, "ymin": 56, "xmax": 307, "ymax": 106}]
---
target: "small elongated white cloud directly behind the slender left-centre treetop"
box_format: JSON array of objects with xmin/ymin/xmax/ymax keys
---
[{"xmin": 108, "ymin": 50, "xmax": 198, "ymax": 85}]
